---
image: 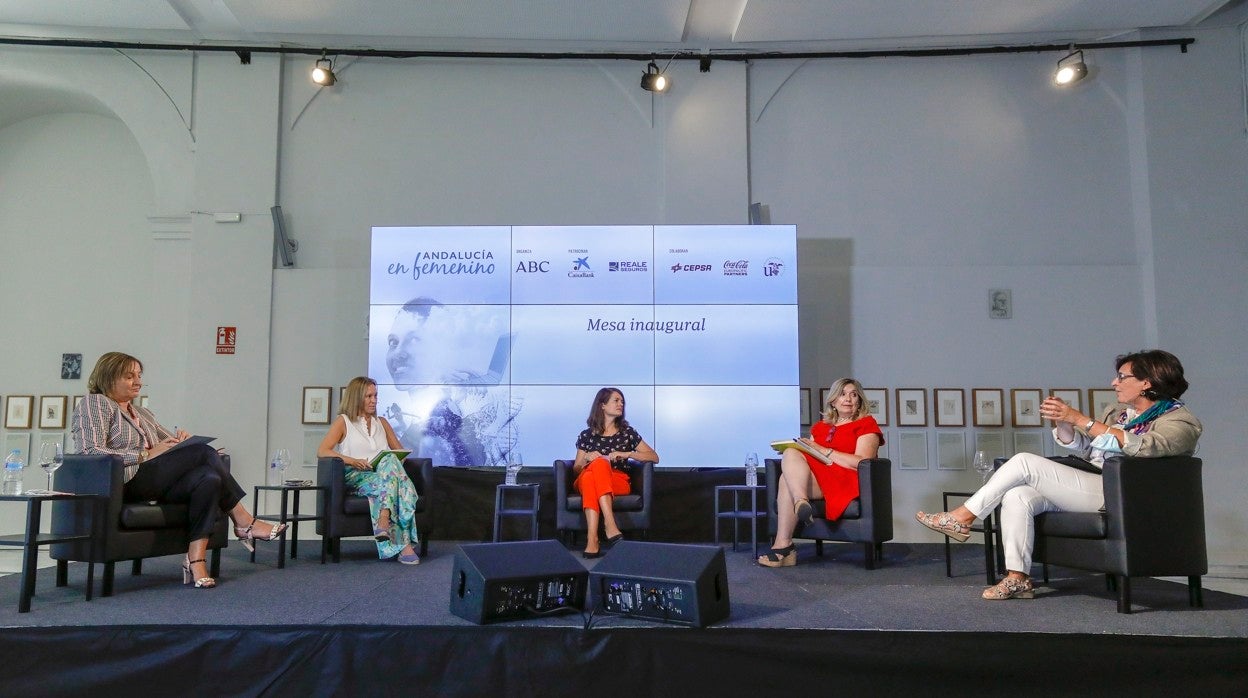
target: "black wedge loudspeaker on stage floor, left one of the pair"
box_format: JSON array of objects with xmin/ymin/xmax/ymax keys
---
[{"xmin": 451, "ymin": 541, "xmax": 589, "ymax": 623}]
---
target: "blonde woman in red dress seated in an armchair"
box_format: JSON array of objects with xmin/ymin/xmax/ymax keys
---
[{"xmin": 759, "ymin": 378, "xmax": 884, "ymax": 567}]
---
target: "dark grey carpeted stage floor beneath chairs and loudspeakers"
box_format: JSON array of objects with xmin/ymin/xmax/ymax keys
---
[{"xmin": 0, "ymin": 539, "xmax": 1248, "ymax": 638}]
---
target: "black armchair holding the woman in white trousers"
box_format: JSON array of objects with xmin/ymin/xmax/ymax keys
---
[{"xmin": 1032, "ymin": 456, "xmax": 1209, "ymax": 613}]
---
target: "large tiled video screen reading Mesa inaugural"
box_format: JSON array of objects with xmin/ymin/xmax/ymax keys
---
[{"xmin": 368, "ymin": 225, "xmax": 800, "ymax": 467}]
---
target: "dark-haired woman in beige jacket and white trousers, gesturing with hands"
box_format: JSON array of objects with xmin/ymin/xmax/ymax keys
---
[{"xmin": 915, "ymin": 350, "xmax": 1201, "ymax": 601}]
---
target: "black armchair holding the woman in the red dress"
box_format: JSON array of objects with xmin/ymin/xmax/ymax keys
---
[{"xmin": 766, "ymin": 458, "xmax": 892, "ymax": 569}]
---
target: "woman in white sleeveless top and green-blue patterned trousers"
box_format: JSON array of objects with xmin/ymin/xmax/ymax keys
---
[{"xmin": 317, "ymin": 376, "xmax": 421, "ymax": 564}]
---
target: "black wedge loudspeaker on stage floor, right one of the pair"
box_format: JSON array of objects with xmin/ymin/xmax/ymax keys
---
[{"xmin": 589, "ymin": 541, "xmax": 729, "ymax": 628}]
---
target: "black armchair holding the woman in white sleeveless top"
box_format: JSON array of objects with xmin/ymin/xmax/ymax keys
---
[{"xmin": 316, "ymin": 458, "xmax": 433, "ymax": 564}]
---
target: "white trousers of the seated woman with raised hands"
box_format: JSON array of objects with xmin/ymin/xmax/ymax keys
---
[{"xmin": 965, "ymin": 453, "xmax": 1104, "ymax": 574}]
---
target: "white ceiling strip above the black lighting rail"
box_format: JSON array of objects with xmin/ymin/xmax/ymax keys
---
[{"xmin": 0, "ymin": 0, "xmax": 1248, "ymax": 51}]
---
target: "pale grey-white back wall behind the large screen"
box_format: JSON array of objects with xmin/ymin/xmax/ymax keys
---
[{"xmin": 0, "ymin": 30, "xmax": 1248, "ymax": 564}]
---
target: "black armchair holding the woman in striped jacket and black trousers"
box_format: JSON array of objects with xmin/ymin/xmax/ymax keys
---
[{"xmin": 50, "ymin": 455, "xmax": 230, "ymax": 596}]
